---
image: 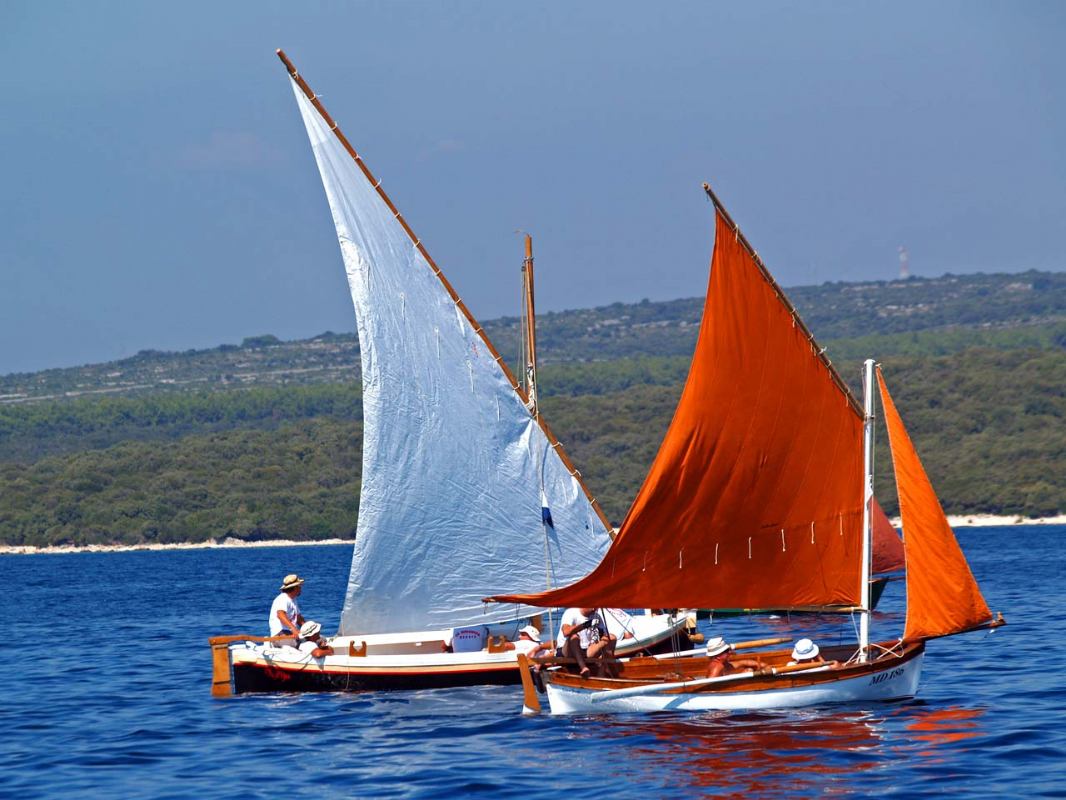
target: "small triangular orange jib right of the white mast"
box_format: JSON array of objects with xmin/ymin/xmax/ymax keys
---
[{"xmin": 877, "ymin": 368, "xmax": 992, "ymax": 641}]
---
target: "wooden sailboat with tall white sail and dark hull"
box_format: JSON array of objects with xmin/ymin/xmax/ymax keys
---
[{"xmin": 211, "ymin": 50, "xmax": 685, "ymax": 695}]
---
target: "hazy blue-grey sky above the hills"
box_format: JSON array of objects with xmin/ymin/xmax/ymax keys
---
[{"xmin": 0, "ymin": 0, "xmax": 1066, "ymax": 373}]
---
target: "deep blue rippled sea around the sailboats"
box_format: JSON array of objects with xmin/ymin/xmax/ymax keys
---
[{"xmin": 0, "ymin": 527, "xmax": 1066, "ymax": 800}]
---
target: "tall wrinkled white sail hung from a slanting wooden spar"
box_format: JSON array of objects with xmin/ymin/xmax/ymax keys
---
[{"xmin": 293, "ymin": 81, "xmax": 610, "ymax": 635}]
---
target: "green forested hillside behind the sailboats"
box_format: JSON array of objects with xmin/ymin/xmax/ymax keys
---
[{"xmin": 0, "ymin": 272, "xmax": 1066, "ymax": 544}]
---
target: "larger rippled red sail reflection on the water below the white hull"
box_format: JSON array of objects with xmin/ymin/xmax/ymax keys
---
[{"xmin": 586, "ymin": 711, "xmax": 883, "ymax": 796}]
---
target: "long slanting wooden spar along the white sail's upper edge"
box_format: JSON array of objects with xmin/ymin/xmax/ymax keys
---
[{"xmin": 277, "ymin": 49, "xmax": 614, "ymax": 539}]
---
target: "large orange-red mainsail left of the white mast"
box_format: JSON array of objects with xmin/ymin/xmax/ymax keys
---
[{"xmin": 497, "ymin": 213, "xmax": 862, "ymax": 609}]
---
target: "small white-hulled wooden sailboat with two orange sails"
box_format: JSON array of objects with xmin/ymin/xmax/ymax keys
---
[{"xmin": 492, "ymin": 185, "xmax": 1004, "ymax": 714}]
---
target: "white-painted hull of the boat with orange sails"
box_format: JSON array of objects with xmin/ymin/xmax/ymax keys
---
[{"xmin": 546, "ymin": 653, "xmax": 924, "ymax": 715}]
